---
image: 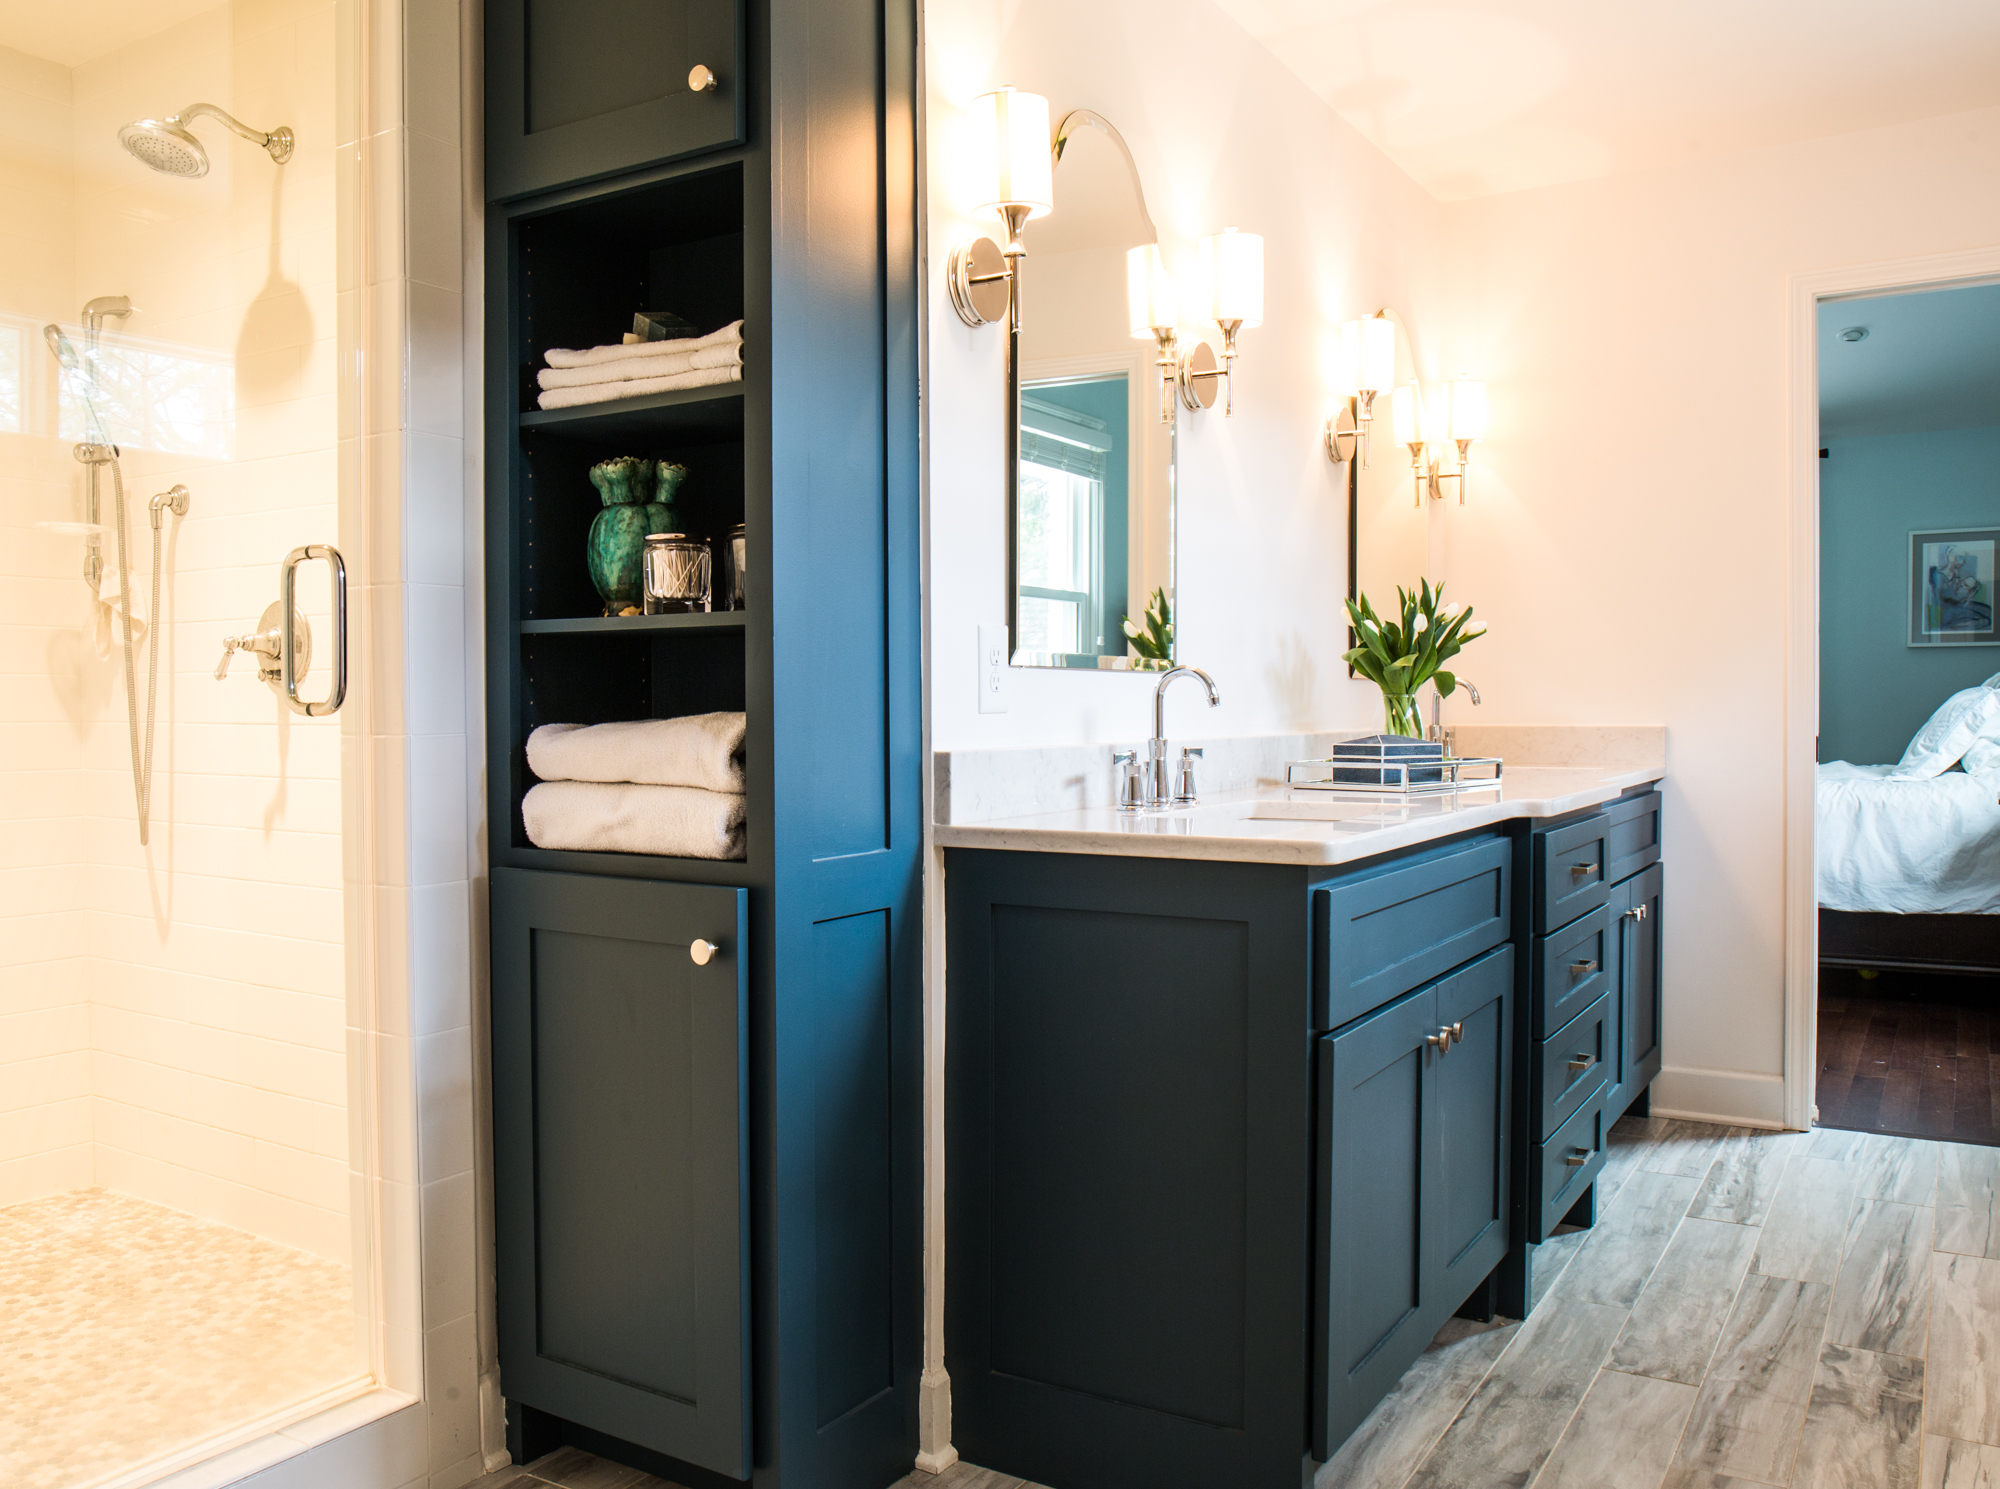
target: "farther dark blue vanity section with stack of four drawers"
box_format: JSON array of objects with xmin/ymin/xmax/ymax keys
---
[{"xmin": 1498, "ymin": 789, "xmax": 1664, "ymax": 1317}]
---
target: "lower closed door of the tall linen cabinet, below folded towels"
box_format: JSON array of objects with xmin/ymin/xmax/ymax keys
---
[{"xmin": 492, "ymin": 869, "xmax": 750, "ymax": 1479}]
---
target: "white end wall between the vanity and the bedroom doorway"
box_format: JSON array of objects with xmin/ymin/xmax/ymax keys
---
[{"xmin": 1438, "ymin": 110, "xmax": 2000, "ymax": 1121}]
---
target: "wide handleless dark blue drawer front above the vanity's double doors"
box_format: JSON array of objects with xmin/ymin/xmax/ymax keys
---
[{"xmin": 1312, "ymin": 837, "xmax": 1504, "ymax": 1029}]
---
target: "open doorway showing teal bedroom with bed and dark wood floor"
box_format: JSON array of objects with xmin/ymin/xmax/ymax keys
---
[{"xmin": 1814, "ymin": 284, "xmax": 2000, "ymax": 1147}]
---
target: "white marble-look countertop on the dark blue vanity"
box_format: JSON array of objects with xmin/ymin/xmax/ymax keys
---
[{"xmin": 932, "ymin": 765, "xmax": 1666, "ymax": 865}]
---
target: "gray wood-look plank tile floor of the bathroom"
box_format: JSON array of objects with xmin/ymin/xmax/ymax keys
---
[{"xmin": 486, "ymin": 1117, "xmax": 2000, "ymax": 1489}]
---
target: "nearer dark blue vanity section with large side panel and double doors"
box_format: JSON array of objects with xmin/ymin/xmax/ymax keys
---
[{"xmin": 944, "ymin": 833, "xmax": 1516, "ymax": 1489}]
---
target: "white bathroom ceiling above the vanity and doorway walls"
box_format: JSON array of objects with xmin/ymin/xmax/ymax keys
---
[{"xmin": 1216, "ymin": 0, "xmax": 2000, "ymax": 200}]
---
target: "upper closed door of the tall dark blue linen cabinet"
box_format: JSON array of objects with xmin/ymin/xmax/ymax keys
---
[{"xmin": 486, "ymin": 0, "xmax": 748, "ymax": 201}]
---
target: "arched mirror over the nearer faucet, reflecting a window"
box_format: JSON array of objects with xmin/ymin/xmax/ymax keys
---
[{"xmin": 1008, "ymin": 110, "xmax": 1174, "ymax": 670}]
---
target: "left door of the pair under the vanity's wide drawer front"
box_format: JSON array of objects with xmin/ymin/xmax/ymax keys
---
[{"xmin": 1312, "ymin": 987, "xmax": 1438, "ymax": 1459}]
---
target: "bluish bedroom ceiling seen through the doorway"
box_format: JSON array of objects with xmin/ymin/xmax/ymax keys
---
[{"xmin": 1820, "ymin": 284, "xmax": 2000, "ymax": 440}]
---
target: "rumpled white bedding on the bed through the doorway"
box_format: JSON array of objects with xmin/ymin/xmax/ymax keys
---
[{"xmin": 1814, "ymin": 761, "xmax": 2000, "ymax": 915}]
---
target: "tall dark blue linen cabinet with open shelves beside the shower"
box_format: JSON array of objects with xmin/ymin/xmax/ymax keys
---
[{"xmin": 484, "ymin": 0, "xmax": 924, "ymax": 1489}]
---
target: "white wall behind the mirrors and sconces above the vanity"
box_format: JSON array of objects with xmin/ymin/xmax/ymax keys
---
[{"xmin": 924, "ymin": 0, "xmax": 1442, "ymax": 749}]
